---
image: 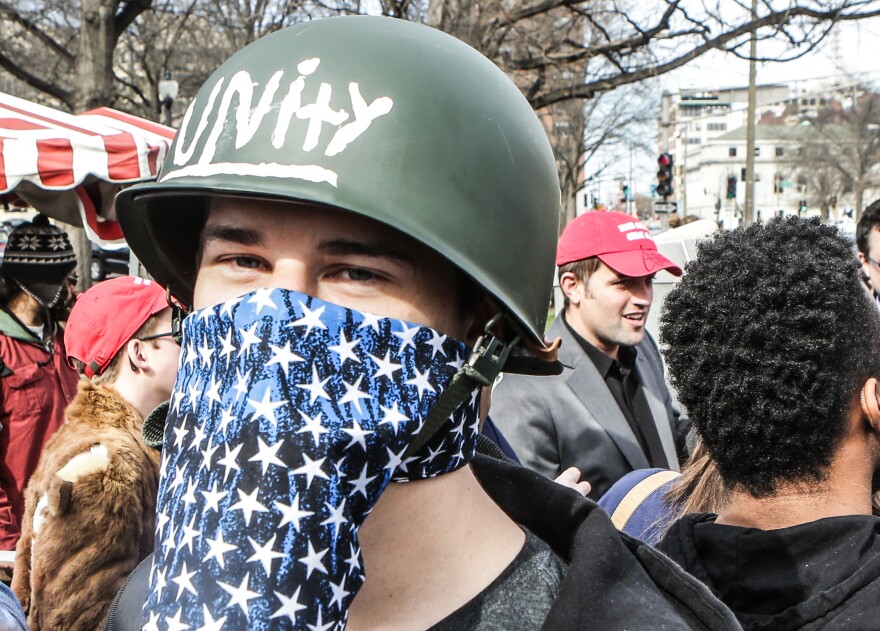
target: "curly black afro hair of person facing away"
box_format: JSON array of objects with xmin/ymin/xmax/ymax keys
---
[{"xmin": 660, "ymin": 217, "xmax": 880, "ymax": 497}]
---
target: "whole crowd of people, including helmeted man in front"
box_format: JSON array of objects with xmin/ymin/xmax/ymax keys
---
[{"xmin": 0, "ymin": 17, "xmax": 880, "ymax": 631}]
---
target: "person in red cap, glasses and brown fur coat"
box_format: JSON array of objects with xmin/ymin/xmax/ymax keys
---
[{"xmin": 12, "ymin": 276, "xmax": 180, "ymax": 631}]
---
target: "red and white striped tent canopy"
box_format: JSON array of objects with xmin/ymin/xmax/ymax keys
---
[{"xmin": 0, "ymin": 92, "xmax": 174, "ymax": 244}]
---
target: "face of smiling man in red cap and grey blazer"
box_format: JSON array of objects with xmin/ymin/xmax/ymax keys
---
[{"xmin": 566, "ymin": 263, "xmax": 654, "ymax": 357}]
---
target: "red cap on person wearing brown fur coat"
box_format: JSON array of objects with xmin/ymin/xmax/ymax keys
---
[{"xmin": 64, "ymin": 276, "xmax": 168, "ymax": 377}]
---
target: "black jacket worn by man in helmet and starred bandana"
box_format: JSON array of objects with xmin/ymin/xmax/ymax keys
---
[{"xmin": 104, "ymin": 456, "xmax": 741, "ymax": 631}]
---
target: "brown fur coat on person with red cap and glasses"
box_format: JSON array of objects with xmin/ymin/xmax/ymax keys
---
[{"xmin": 12, "ymin": 381, "xmax": 159, "ymax": 631}]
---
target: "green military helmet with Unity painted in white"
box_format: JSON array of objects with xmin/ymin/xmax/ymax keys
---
[{"xmin": 117, "ymin": 16, "xmax": 560, "ymax": 342}]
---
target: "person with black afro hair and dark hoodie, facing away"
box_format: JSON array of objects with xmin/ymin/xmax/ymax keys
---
[{"xmin": 660, "ymin": 218, "xmax": 880, "ymax": 629}]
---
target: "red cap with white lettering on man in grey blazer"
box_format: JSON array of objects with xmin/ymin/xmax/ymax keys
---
[{"xmin": 556, "ymin": 210, "xmax": 681, "ymax": 277}]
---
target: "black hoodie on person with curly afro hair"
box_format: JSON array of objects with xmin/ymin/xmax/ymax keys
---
[{"xmin": 659, "ymin": 514, "xmax": 880, "ymax": 631}]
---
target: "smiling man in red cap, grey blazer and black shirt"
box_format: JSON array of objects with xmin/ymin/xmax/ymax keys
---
[{"xmin": 492, "ymin": 212, "xmax": 687, "ymax": 499}]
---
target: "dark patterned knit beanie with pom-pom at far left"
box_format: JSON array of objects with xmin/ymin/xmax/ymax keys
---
[{"xmin": 0, "ymin": 215, "xmax": 76, "ymax": 309}]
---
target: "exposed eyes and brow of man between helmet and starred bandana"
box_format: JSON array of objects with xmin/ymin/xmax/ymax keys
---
[{"xmin": 193, "ymin": 197, "xmax": 472, "ymax": 340}]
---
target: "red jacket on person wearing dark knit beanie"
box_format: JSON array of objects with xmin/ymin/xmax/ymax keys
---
[{"xmin": 0, "ymin": 311, "xmax": 79, "ymax": 550}]
